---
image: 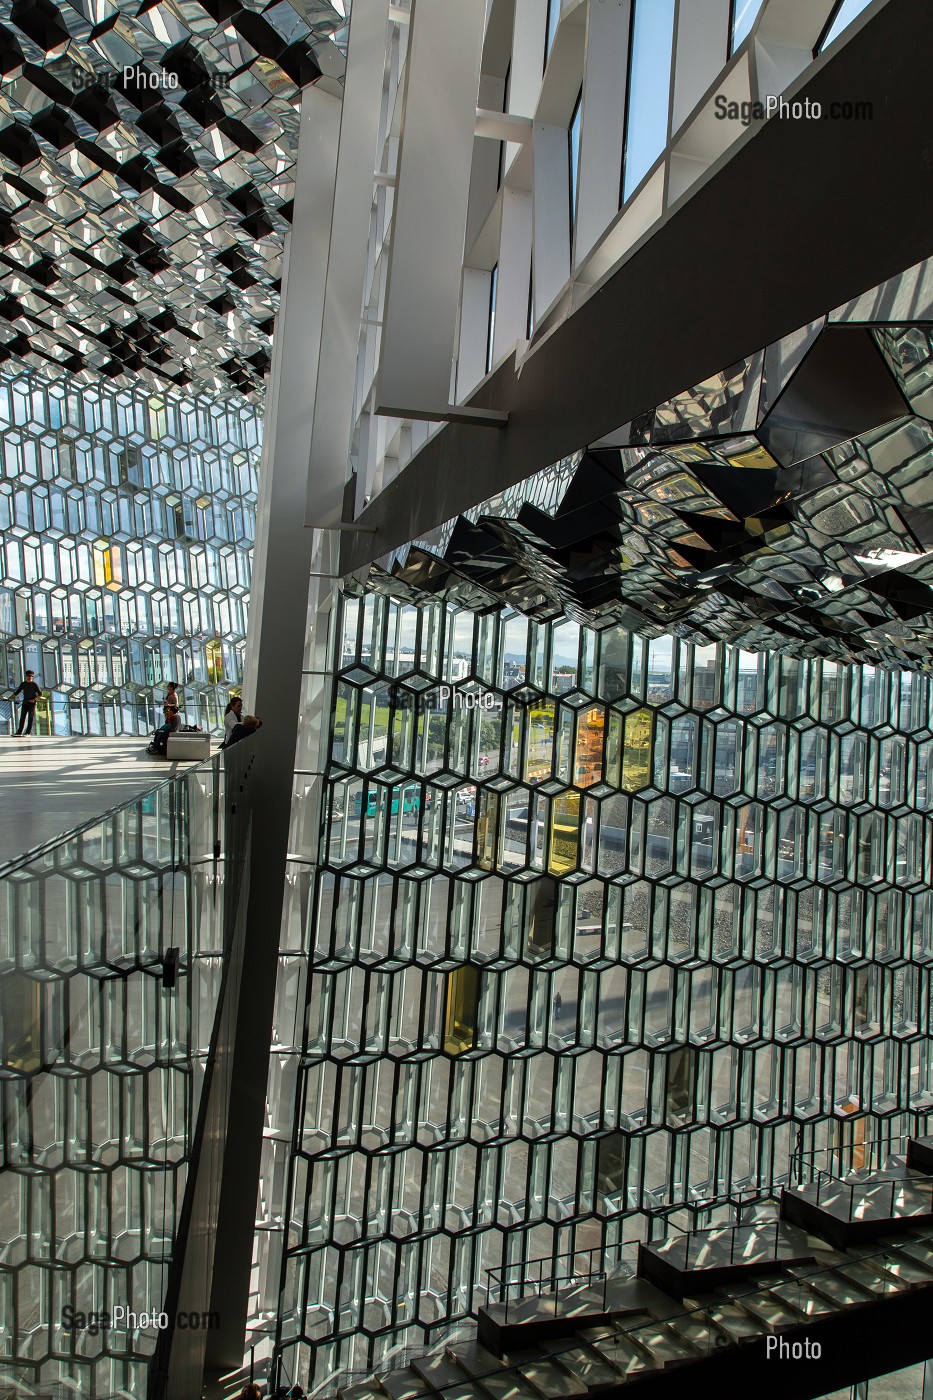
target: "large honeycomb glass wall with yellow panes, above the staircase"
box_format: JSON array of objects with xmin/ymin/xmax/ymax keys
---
[{"xmin": 265, "ymin": 582, "xmax": 933, "ymax": 1379}]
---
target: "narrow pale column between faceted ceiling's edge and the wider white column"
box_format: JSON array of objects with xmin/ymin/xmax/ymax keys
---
[{"xmin": 305, "ymin": 0, "xmax": 389, "ymax": 526}]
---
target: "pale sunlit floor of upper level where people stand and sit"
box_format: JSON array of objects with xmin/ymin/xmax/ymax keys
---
[{"xmin": 0, "ymin": 735, "xmax": 205, "ymax": 868}]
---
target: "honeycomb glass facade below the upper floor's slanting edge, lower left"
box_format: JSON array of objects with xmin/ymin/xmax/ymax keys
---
[{"xmin": 0, "ymin": 745, "xmax": 251, "ymax": 1400}]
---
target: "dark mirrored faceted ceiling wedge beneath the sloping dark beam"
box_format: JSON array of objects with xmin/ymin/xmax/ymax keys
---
[{"xmin": 361, "ymin": 313, "xmax": 933, "ymax": 669}]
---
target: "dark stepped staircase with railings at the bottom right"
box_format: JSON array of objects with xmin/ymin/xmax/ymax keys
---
[{"xmin": 312, "ymin": 1140, "xmax": 933, "ymax": 1400}]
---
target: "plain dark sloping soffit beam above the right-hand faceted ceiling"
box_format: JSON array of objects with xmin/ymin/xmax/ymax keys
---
[{"xmin": 340, "ymin": 0, "xmax": 933, "ymax": 573}]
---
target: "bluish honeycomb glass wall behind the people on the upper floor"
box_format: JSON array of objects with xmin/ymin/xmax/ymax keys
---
[{"xmin": 0, "ymin": 368, "xmax": 262, "ymax": 734}]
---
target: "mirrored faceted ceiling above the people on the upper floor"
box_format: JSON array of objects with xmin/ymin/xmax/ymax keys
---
[{"xmin": 0, "ymin": 0, "xmax": 346, "ymax": 396}]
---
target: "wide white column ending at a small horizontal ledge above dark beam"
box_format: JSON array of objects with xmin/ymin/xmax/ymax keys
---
[{"xmin": 377, "ymin": 0, "xmax": 486, "ymax": 420}]
